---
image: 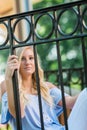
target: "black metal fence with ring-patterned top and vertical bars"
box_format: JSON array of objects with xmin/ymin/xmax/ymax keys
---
[{"xmin": 0, "ymin": 0, "xmax": 87, "ymax": 130}]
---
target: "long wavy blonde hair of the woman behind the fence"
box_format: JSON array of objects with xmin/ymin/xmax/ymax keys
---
[{"xmin": 17, "ymin": 46, "xmax": 53, "ymax": 106}]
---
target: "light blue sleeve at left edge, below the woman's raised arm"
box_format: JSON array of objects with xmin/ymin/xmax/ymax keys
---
[{"xmin": 1, "ymin": 93, "xmax": 11, "ymax": 124}]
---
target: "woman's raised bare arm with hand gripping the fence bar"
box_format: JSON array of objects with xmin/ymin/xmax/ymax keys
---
[{"xmin": 5, "ymin": 55, "xmax": 24, "ymax": 117}]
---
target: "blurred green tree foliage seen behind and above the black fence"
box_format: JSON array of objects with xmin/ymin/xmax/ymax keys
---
[{"xmin": 33, "ymin": 0, "xmax": 87, "ymax": 89}]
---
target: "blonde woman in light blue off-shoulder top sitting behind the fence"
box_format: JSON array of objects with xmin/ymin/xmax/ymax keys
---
[{"xmin": 1, "ymin": 47, "xmax": 87, "ymax": 130}]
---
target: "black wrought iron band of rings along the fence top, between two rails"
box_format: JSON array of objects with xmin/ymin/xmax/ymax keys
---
[{"xmin": 0, "ymin": 1, "xmax": 87, "ymax": 49}]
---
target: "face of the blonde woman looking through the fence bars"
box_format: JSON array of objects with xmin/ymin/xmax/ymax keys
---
[{"xmin": 20, "ymin": 48, "xmax": 35, "ymax": 77}]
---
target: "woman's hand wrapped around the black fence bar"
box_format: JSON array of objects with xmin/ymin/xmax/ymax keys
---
[{"xmin": 5, "ymin": 55, "xmax": 19, "ymax": 79}]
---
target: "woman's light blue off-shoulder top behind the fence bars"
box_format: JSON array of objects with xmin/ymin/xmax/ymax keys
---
[{"xmin": 1, "ymin": 88, "xmax": 65, "ymax": 130}]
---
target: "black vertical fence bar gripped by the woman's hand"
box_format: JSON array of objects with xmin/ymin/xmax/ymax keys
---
[{"xmin": 8, "ymin": 19, "xmax": 22, "ymax": 130}]
